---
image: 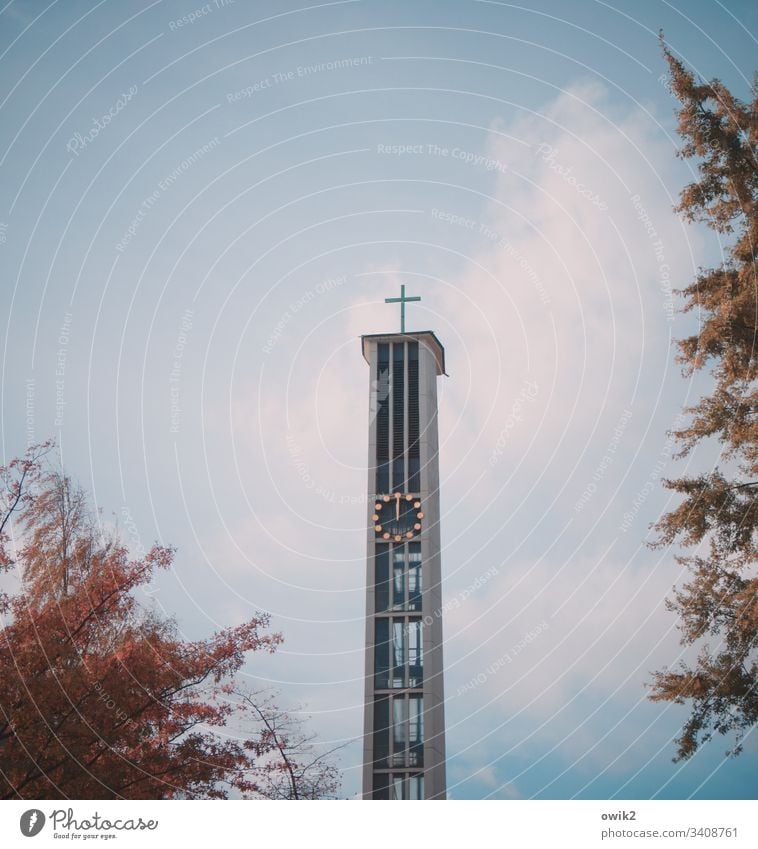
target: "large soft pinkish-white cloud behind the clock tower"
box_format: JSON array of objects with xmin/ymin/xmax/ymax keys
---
[{"xmin": 197, "ymin": 79, "xmax": 712, "ymax": 793}]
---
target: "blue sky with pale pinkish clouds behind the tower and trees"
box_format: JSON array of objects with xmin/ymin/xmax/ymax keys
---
[{"xmin": 0, "ymin": 0, "xmax": 758, "ymax": 799}]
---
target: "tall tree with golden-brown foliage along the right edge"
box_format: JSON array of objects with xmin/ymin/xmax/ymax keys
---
[{"xmin": 650, "ymin": 39, "xmax": 758, "ymax": 760}]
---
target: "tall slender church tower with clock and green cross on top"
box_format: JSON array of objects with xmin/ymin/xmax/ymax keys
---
[{"xmin": 361, "ymin": 286, "xmax": 446, "ymax": 799}]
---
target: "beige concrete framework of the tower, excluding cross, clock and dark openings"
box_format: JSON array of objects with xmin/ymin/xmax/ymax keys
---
[{"xmin": 362, "ymin": 331, "xmax": 446, "ymax": 799}]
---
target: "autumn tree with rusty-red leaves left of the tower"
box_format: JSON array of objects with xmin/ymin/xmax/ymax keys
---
[{"xmin": 0, "ymin": 446, "xmax": 342, "ymax": 799}]
